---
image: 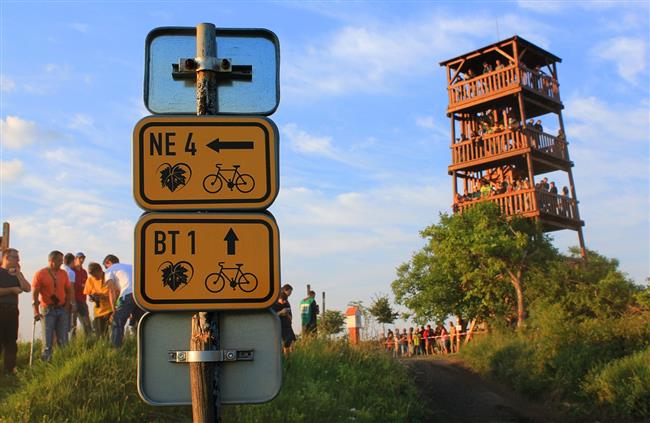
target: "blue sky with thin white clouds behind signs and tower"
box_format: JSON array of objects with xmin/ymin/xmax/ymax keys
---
[{"xmin": 0, "ymin": 0, "xmax": 650, "ymax": 335}]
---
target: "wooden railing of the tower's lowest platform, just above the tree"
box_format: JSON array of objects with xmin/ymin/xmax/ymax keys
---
[{"xmin": 455, "ymin": 188, "xmax": 578, "ymax": 220}]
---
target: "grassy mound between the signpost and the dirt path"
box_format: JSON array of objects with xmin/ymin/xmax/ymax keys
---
[{"xmin": 224, "ymin": 338, "xmax": 425, "ymax": 422}]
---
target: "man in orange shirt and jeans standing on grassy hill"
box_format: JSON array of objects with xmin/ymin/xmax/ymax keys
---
[{"xmin": 32, "ymin": 250, "xmax": 76, "ymax": 361}]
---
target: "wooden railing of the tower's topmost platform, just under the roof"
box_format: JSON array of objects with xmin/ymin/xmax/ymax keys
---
[{"xmin": 447, "ymin": 65, "xmax": 560, "ymax": 107}]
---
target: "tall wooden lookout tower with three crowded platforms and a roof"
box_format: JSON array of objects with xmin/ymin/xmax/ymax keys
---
[{"xmin": 440, "ymin": 36, "xmax": 585, "ymax": 256}]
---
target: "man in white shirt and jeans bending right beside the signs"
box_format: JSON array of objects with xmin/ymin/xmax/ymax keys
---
[{"xmin": 104, "ymin": 254, "xmax": 143, "ymax": 347}]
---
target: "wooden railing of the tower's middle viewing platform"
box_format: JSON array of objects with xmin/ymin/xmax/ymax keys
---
[{"xmin": 451, "ymin": 128, "xmax": 569, "ymax": 165}]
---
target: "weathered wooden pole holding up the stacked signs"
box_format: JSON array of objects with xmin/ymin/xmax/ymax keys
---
[{"xmin": 188, "ymin": 23, "xmax": 220, "ymax": 423}]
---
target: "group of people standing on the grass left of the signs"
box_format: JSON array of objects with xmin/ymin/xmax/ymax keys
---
[{"xmin": 0, "ymin": 248, "xmax": 144, "ymax": 373}]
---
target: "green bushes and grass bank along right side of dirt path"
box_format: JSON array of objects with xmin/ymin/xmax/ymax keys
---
[{"xmin": 461, "ymin": 307, "xmax": 650, "ymax": 418}]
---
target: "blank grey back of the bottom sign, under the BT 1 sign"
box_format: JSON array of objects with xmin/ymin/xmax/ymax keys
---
[{"xmin": 138, "ymin": 310, "xmax": 282, "ymax": 406}]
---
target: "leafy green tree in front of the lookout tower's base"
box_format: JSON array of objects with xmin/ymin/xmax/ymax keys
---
[{"xmin": 393, "ymin": 202, "xmax": 558, "ymax": 326}]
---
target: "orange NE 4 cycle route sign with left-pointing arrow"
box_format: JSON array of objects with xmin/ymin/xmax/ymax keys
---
[{"xmin": 133, "ymin": 116, "xmax": 278, "ymax": 210}]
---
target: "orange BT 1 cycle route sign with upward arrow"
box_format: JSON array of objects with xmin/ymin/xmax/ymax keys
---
[{"xmin": 133, "ymin": 213, "xmax": 280, "ymax": 311}]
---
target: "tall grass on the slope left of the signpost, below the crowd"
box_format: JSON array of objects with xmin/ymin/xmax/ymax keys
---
[{"xmin": 0, "ymin": 337, "xmax": 191, "ymax": 422}]
